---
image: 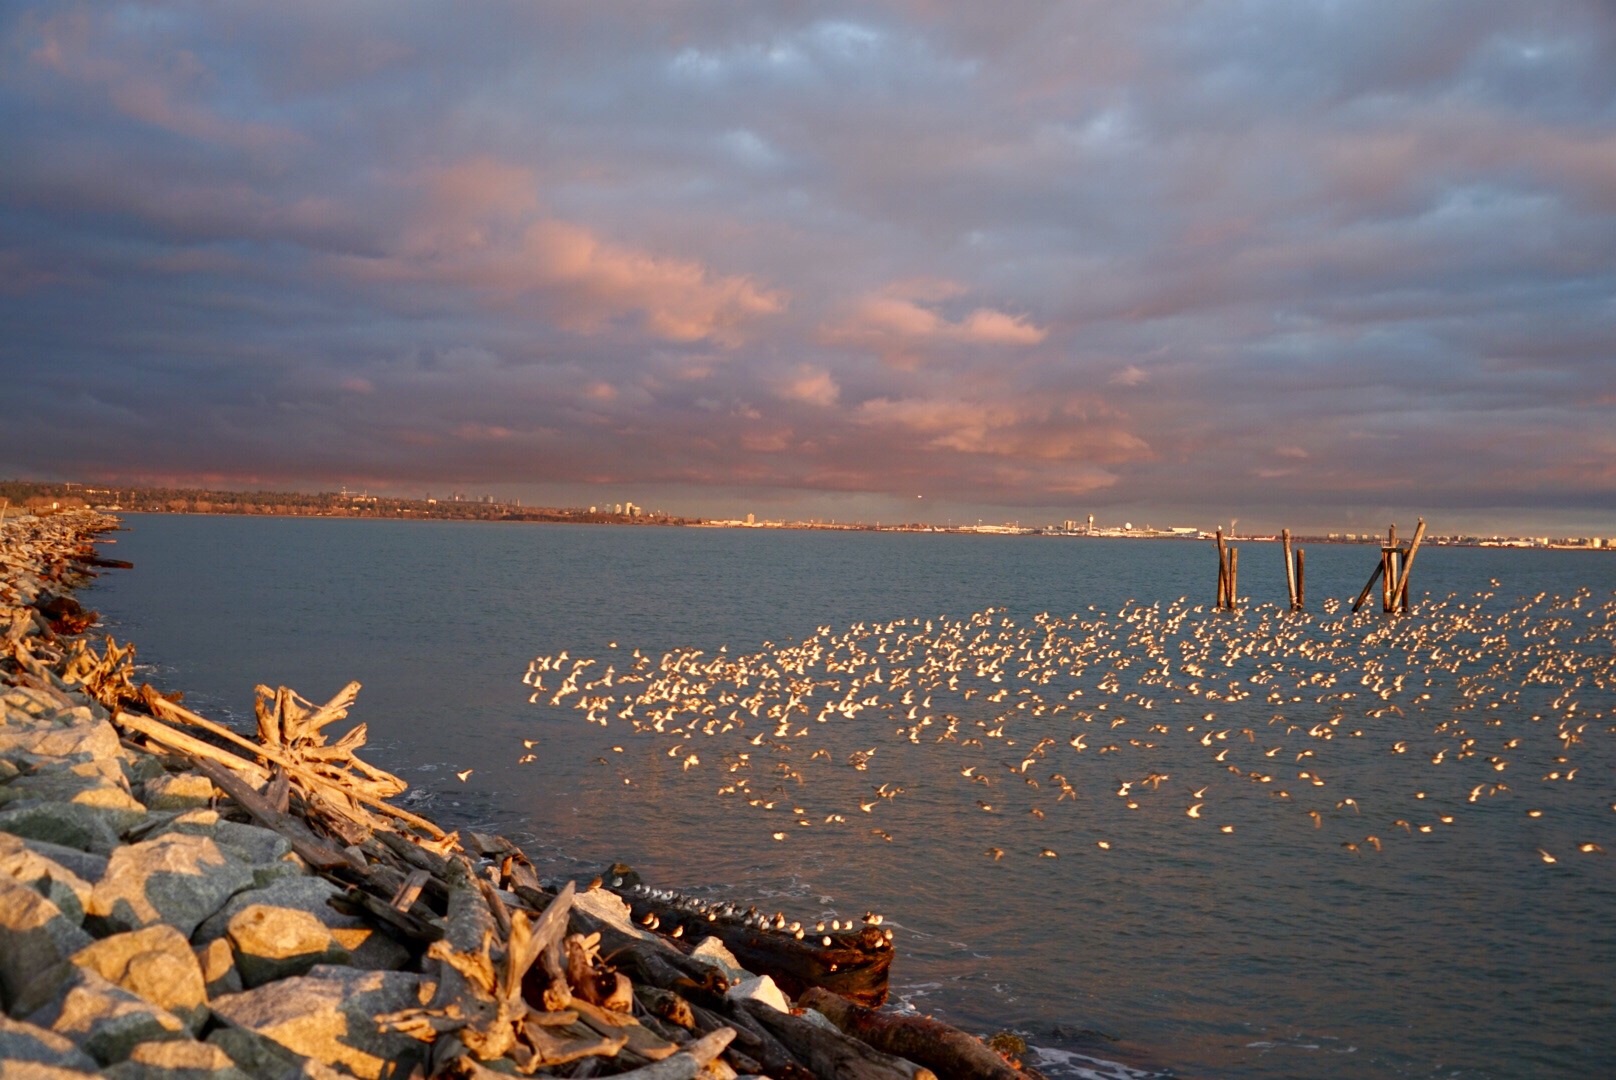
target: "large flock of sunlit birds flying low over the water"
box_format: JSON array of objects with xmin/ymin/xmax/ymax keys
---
[{"xmin": 513, "ymin": 582, "xmax": 1616, "ymax": 863}]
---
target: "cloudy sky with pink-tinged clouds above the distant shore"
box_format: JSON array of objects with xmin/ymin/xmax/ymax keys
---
[{"xmin": 0, "ymin": 0, "xmax": 1616, "ymax": 535}]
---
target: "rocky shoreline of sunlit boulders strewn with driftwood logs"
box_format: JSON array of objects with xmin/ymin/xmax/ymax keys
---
[{"xmin": 0, "ymin": 511, "xmax": 1036, "ymax": 1080}]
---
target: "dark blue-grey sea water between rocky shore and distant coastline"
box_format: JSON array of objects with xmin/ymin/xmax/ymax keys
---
[{"xmin": 86, "ymin": 516, "xmax": 1616, "ymax": 1078}]
